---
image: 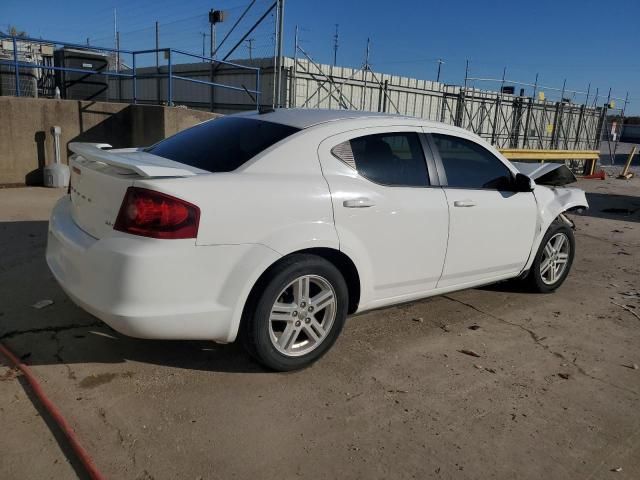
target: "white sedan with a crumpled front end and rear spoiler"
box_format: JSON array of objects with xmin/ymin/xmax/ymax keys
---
[{"xmin": 47, "ymin": 110, "xmax": 587, "ymax": 370}]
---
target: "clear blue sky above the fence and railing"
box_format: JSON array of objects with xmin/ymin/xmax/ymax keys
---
[{"xmin": 0, "ymin": 0, "xmax": 640, "ymax": 113}]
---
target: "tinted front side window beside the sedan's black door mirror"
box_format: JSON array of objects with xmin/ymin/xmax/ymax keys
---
[{"xmin": 432, "ymin": 134, "xmax": 512, "ymax": 190}]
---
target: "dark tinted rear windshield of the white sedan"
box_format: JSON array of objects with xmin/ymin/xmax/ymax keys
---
[{"xmin": 145, "ymin": 117, "xmax": 299, "ymax": 172}]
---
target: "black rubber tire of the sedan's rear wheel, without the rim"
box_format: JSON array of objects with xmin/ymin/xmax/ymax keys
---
[{"xmin": 241, "ymin": 254, "xmax": 349, "ymax": 372}]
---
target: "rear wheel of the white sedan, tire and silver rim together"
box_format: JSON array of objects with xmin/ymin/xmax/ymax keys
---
[{"xmin": 243, "ymin": 255, "xmax": 348, "ymax": 371}]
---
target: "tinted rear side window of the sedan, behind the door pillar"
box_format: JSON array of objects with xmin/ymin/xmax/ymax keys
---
[{"xmin": 331, "ymin": 132, "xmax": 429, "ymax": 187}]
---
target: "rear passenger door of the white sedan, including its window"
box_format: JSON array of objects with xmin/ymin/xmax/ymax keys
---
[{"xmin": 318, "ymin": 127, "xmax": 449, "ymax": 309}]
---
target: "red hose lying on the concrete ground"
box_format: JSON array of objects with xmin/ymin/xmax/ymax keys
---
[{"xmin": 0, "ymin": 343, "xmax": 105, "ymax": 480}]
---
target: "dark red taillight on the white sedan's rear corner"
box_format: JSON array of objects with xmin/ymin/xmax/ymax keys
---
[{"xmin": 113, "ymin": 187, "xmax": 200, "ymax": 239}]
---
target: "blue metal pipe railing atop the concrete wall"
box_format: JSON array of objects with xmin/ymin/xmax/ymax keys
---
[{"xmin": 0, "ymin": 33, "xmax": 261, "ymax": 109}]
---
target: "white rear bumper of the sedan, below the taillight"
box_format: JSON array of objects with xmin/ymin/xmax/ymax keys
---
[{"xmin": 46, "ymin": 197, "xmax": 277, "ymax": 342}]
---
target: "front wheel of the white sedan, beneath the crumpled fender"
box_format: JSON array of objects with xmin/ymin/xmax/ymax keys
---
[{"xmin": 526, "ymin": 220, "xmax": 575, "ymax": 293}]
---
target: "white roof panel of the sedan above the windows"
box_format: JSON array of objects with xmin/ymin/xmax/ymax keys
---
[{"xmin": 237, "ymin": 108, "xmax": 429, "ymax": 129}]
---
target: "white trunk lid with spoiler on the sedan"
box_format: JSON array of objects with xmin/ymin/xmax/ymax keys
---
[{"xmin": 69, "ymin": 143, "xmax": 207, "ymax": 238}]
